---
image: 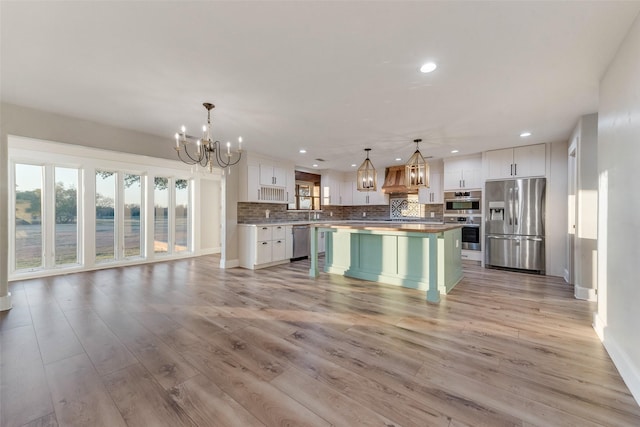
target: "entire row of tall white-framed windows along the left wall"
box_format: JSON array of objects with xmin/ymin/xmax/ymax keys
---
[{"xmin": 7, "ymin": 135, "xmax": 208, "ymax": 279}]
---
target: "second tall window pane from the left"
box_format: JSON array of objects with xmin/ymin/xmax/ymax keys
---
[{"xmin": 54, "ymin": 167, "xmax": 78, "ymax": 265}]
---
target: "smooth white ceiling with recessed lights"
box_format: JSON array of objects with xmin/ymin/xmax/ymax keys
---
[{"xmin": 0, "ymin": 0, "xmax": 640, "ymax": 170}]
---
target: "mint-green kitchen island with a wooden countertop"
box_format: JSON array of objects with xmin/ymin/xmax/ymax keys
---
[{"xmin": 309, "ymin": 222, "xmax": 462, "ymax": 303}]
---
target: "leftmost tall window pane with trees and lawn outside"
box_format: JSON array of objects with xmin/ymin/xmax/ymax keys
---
[{"xmin": 14, "ymin": 164, "xmax": 43, "ymax": 270}]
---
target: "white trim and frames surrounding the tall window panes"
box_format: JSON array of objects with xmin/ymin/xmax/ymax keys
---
[{"xmin": 7, "ymin": 135, "xmax": 222, "ymax": 281}]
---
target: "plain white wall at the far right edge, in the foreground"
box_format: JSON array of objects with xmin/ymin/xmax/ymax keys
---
[{"xmin": 595, "ymin": 18, "xmax": 640, "ymax": 402}]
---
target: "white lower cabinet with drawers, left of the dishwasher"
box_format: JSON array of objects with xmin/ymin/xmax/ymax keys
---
[{"xmin": 238, "ymin": 224, "xmax": 291, "ymax": 270}]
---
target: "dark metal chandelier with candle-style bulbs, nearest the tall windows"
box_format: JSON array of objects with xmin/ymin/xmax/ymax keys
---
[{"xmin": 175, "ymin": 102, "xmax": 242, "ymax": 172}]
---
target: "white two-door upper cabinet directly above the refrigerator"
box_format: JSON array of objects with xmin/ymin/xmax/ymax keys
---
[{"xmin": 484, "ymin": 144, "xmax": 547, "ymax": 179}]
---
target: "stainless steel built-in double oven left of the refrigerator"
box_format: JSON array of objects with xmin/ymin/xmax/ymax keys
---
[{"xmin": 444, "ymin": 190, "xmax": 482, "ymax": 261}]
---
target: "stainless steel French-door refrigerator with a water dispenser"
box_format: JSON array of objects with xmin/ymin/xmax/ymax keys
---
[{"xmin": 484, "ymin": 178, "xmax": 546, "ymax": 274}]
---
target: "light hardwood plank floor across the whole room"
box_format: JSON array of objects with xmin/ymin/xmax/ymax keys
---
[{"xmin": 0, "ymin": 256, "xmax": 640, "ymax": 427}]
